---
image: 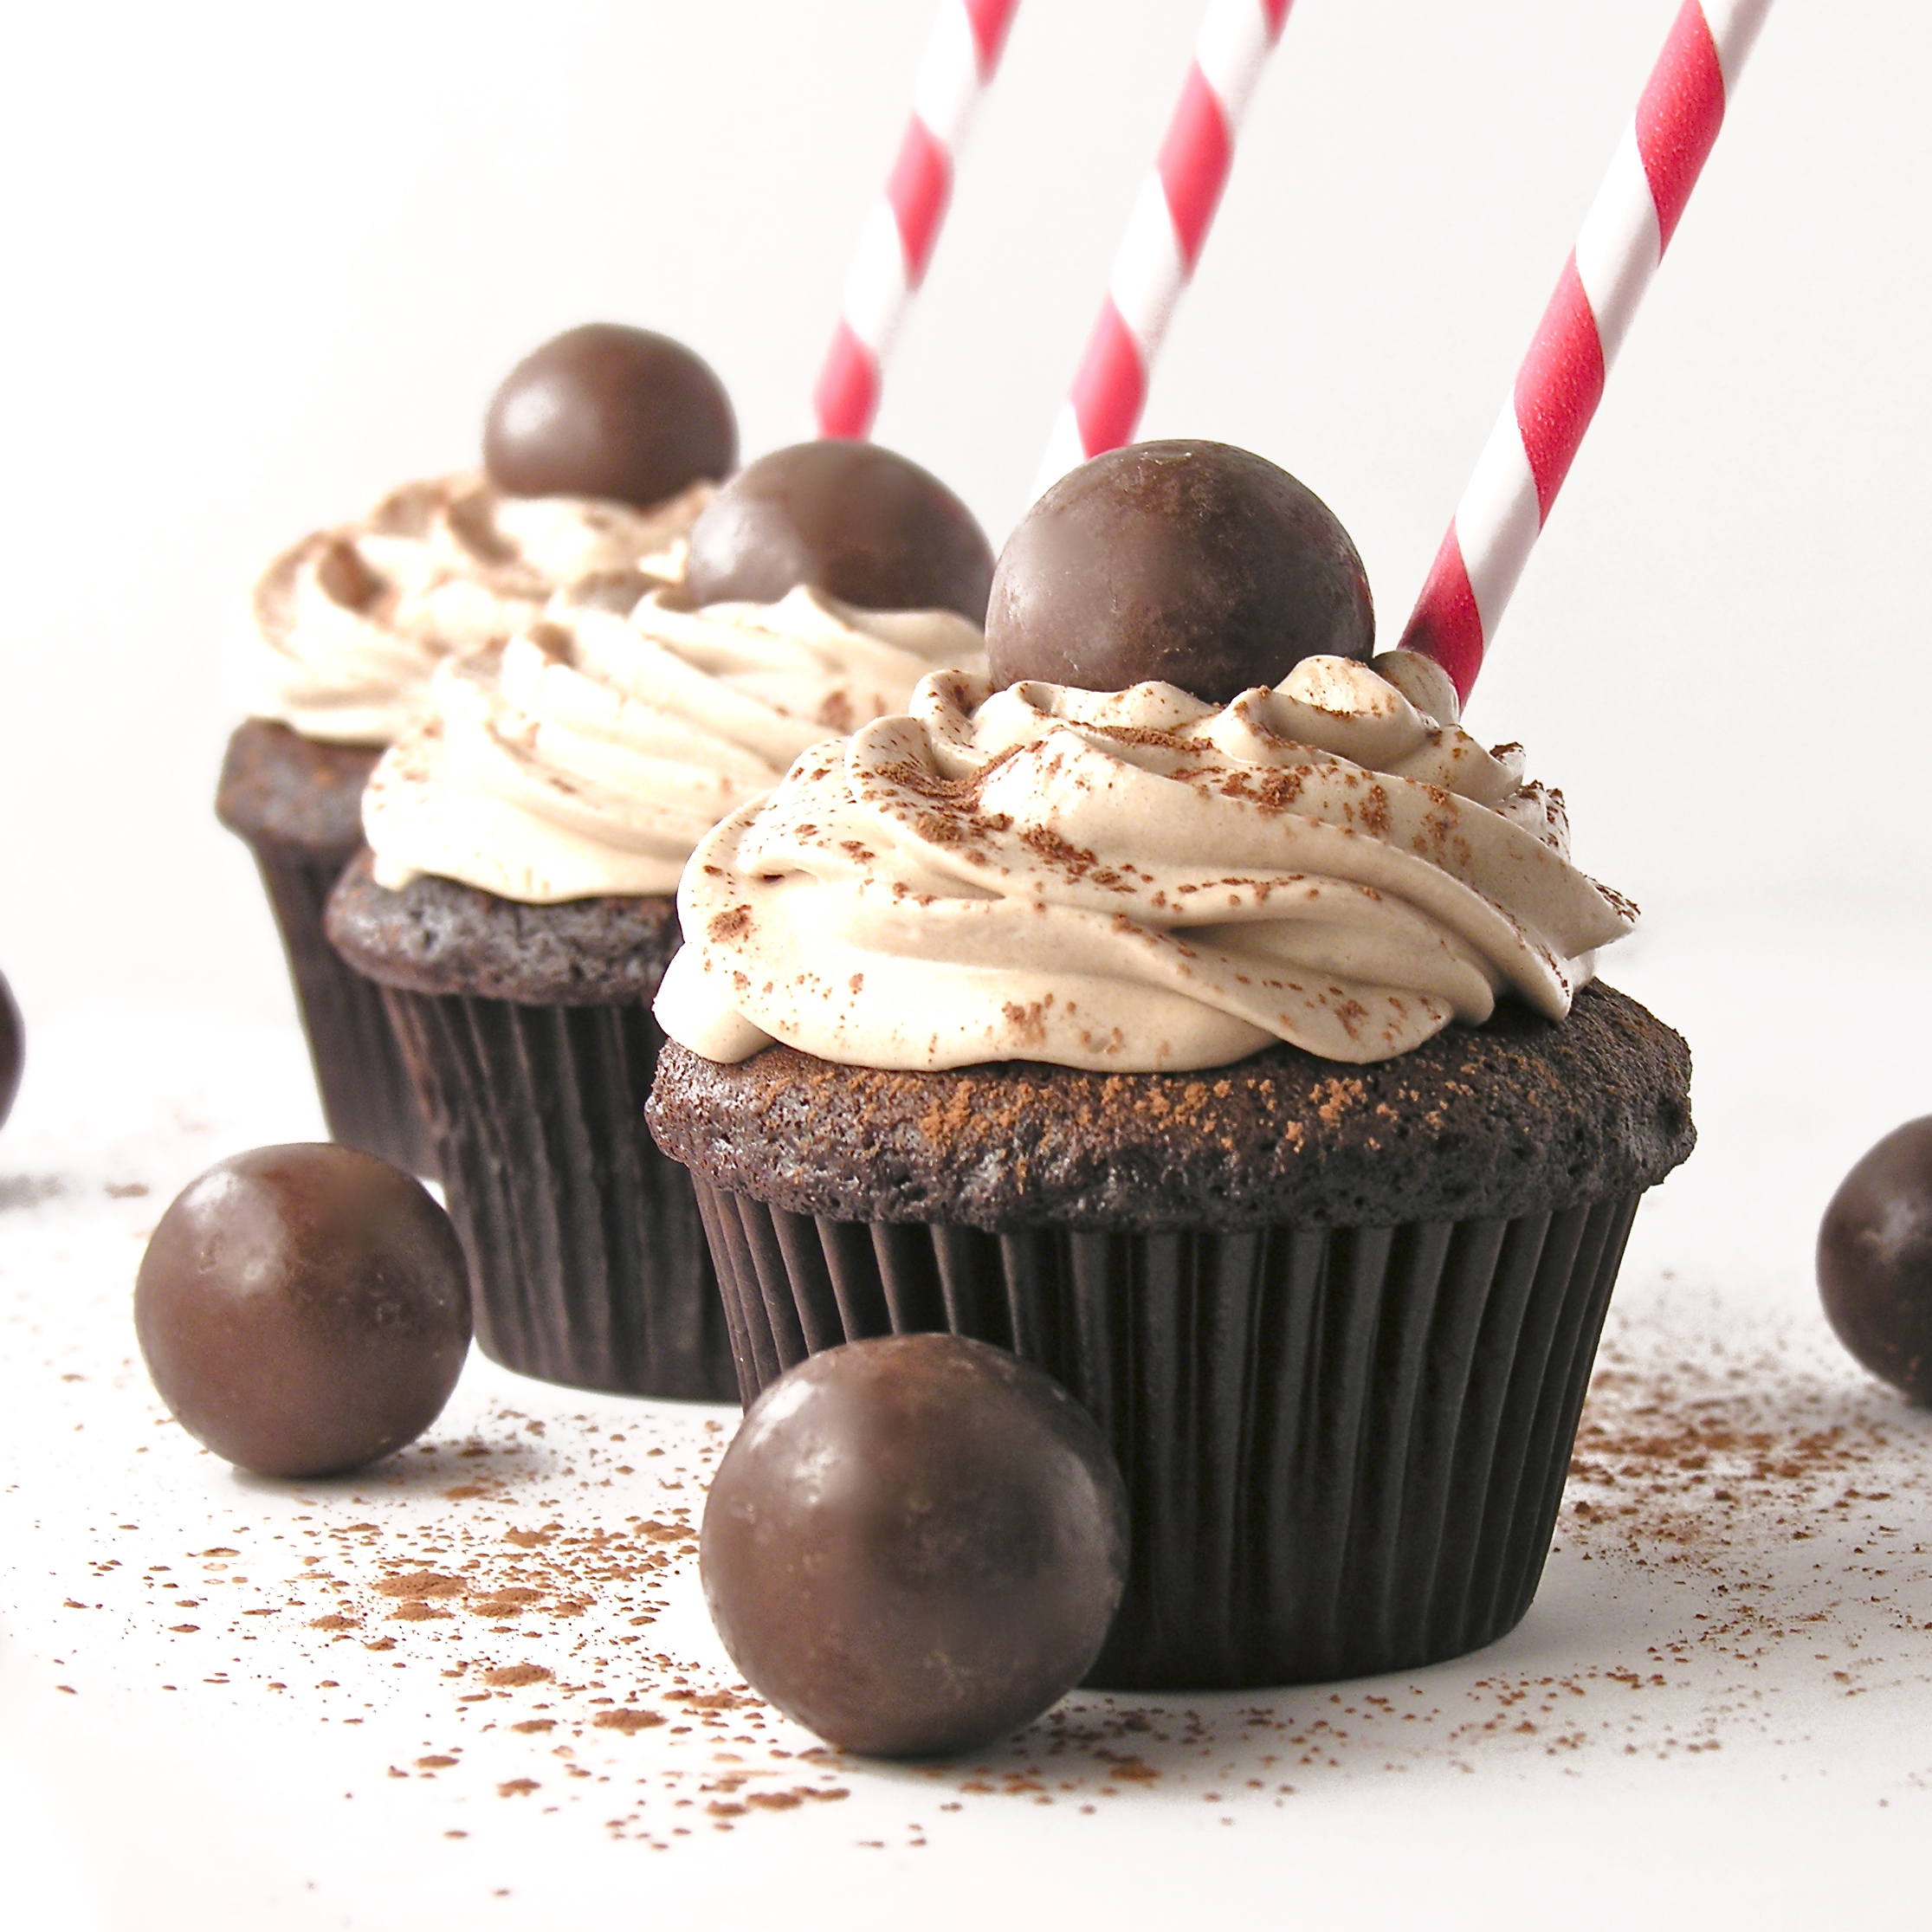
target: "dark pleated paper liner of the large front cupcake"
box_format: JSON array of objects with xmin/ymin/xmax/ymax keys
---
[{"xmin": 697, "ymin": 1182, "xmax": 1638, "ymax": 1689}]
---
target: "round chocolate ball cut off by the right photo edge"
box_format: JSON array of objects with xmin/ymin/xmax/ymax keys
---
[{"xmin": 1818, "ymin": 1115, "xmax": 1932, "ymax": 1403}]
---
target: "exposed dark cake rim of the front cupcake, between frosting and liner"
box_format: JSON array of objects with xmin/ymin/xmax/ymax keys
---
[{"xmin": 649, "ymin": 985, "xmax": 1696, "ymax": 1231}]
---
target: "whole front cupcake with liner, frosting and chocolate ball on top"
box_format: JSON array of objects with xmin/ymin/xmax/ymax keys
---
[{"xmin": 649, "ymin": 444, "xmax": 1692, "ymax": 1689}]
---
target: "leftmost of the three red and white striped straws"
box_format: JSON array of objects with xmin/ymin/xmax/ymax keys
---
[{"xmin": 811, "ymin": 0, "xmax": 1020, "ymax": 438}]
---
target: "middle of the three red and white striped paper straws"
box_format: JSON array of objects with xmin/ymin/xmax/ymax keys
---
[{"xmin": 1034, "ymin": 0, "xmax": 1293, "ymax": 496}]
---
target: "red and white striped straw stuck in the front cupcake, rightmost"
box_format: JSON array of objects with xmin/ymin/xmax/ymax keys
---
[{"xmin": 1403, "ymin": 0, "xmax": 1772, "ymax": 697}]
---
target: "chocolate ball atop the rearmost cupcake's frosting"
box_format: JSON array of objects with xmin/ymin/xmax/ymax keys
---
[{"xmin": 483, "ymin": 323, "xmax": 738, "ymax": 507}]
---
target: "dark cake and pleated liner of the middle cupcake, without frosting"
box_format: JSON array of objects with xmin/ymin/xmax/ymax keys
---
[{"xmin": 328, "ymin": 852, "xmax": 714, "ymax": 1400}]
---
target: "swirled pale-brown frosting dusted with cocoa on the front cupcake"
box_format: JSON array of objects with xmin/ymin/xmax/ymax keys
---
[{"xmin": 657, "ymin": 657, "xmax": 1634, "ymax": 1072}]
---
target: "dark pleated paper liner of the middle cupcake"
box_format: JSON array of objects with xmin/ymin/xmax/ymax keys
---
[{"xmin": 383, "ymin": 987, "xmax": 738, "ymax": 1400}]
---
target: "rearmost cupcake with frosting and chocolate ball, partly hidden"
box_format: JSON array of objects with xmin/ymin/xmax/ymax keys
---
[{"xmin": 216, "ymin": 323, "xmax": 738, "ymax": 1173}]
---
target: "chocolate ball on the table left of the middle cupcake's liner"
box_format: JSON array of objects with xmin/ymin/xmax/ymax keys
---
[{"xmin": 133, "ymin": 1146, "xmax": 469, "ymax": 1476}]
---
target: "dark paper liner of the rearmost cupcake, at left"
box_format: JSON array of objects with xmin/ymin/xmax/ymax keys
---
[{"xmin": 249, "ymin": 838, "xmax": 436, "ymax": 1177}]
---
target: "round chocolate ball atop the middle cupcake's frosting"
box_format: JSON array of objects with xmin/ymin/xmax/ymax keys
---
[{"xmin": 684, "ymin": 441, "xmax": 993, "ymax": 624}]
